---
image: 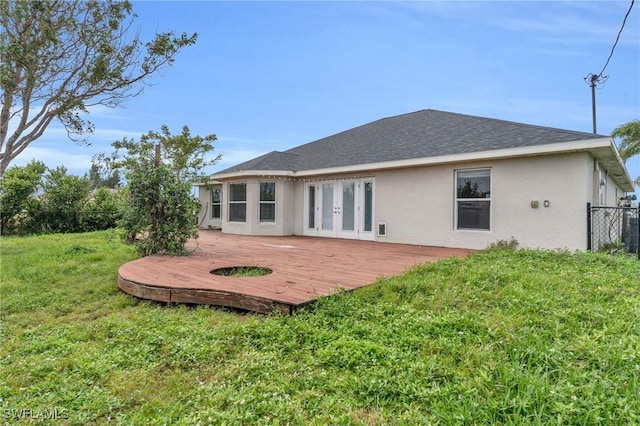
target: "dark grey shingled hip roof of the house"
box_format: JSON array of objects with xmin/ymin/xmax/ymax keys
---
[{"xmin": 213, "ymin": 109, "xmax": 620, "ymax": 177}]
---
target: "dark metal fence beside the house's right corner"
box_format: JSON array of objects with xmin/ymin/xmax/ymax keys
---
[{"xmin": 587, "ymin": 203, "xmax": 640, "ymax": 259}]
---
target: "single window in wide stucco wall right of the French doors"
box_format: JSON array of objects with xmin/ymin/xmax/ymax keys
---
[{"xmin": 456, "ymin": 169, "xmax": 491, "ymax": 231}]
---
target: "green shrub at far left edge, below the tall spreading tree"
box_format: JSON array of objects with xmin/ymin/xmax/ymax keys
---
[{"xmin": 0, "ymin": 160, "xmax": 47, "ymax": 235}]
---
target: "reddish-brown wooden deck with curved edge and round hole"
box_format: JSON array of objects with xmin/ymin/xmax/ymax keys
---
[{"xmin": 118, "ymin": 230, "xmax": 471, "ymax": 314}]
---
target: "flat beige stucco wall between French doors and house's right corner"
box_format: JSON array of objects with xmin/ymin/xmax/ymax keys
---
[{"xmin": 375, "ymin": 153, "xmax": 593, "ymax": 250}]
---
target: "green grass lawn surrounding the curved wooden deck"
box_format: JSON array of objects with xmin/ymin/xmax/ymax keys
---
[{"xmin": 0, "ymin": 231, "xmax": 640, "ymax": 425}]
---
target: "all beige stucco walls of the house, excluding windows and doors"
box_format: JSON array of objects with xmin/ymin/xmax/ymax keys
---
[{"xmin": 200, "ymin": 152, "xmax": 623, "ymax": 250}]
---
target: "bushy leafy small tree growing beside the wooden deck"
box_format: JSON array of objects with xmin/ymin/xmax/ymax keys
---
[{"xmin": 113, "ymin": 126, "xmax": 219, "ymax": 256}]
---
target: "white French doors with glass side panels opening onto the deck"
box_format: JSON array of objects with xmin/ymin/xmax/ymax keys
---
[{"xmin": 304, "ymin": 179, "xmax": 374, "ymax": 240}]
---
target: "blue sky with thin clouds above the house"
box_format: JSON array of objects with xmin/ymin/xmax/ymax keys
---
[{"xmin": 15, "ymin": 0, "xmax": 640, "ymax": 192}]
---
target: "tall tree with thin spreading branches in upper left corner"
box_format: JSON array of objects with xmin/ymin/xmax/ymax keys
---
[{"xmin": 0, "ymin": 0, "xmax": 197, "ymax": 175}]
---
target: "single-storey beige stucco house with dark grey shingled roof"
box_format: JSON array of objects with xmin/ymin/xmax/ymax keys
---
[{"xmin": 199, "ymin": 110, "xmax": 634, "ymax": 250}]
